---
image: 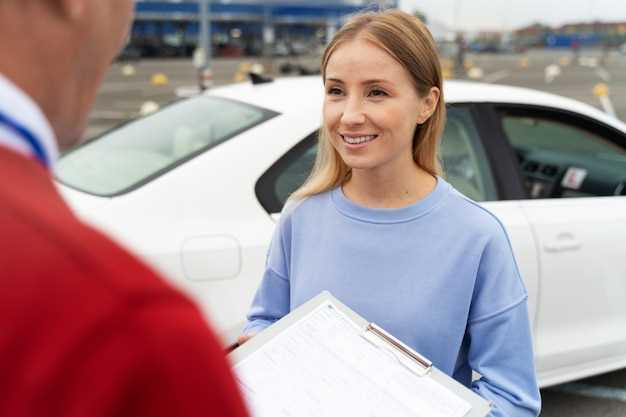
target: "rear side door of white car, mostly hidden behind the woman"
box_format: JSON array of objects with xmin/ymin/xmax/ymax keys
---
[{"xmin": 256, "ymin": 105, "xmax": 538, "ymax": 332}]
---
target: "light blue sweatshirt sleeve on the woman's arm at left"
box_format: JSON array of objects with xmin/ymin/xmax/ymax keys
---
[{"xmin": 243, "ymin": 211, "xmax": 291, "ymax": 334}]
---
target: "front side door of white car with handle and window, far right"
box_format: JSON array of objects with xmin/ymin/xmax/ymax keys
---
[{"xmin": 490, "ymin": 106, "xmax": 626, "ymax": 383}]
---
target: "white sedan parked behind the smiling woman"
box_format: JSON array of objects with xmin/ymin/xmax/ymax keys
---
[{"xmin": 57, "ymin": 77, "xmax": 626, "ymax": 386}]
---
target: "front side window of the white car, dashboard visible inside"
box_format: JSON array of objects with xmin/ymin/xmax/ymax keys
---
[{"xmin": 500, "ymin": 109, "xmax": 626, "ymax": 198}]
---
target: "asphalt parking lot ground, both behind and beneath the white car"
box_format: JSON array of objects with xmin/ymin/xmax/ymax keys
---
[{"xmin": 86, "ymin": 50, "xmax": 626, "ymax": 417}]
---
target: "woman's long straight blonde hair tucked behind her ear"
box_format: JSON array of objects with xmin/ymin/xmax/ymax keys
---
[{"xmin": 291, "ymin": 10, "xmax": 446, "ymax": 199}]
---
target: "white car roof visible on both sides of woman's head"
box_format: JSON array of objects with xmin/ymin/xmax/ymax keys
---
[{"xmin": 206, "ymin": 75, "xmax": 626, "ymax": 131}]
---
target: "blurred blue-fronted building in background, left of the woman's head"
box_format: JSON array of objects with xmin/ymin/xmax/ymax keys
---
[{"xmin": 129, "ymin": 0, "xmax": 398, "ymax": 57}]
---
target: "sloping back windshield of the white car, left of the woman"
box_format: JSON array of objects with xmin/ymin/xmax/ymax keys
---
[{"xmin": 55, "ymin": 96, "xmax": 276, "ymax": 197}]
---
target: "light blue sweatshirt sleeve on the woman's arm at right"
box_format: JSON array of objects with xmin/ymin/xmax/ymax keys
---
[{"xmin": 467, "ymin": 224, "xmax": 541, "ymax": 417}]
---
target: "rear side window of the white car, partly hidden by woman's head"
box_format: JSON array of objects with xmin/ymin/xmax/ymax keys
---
[{"xmin": 256, "ymin": 107, "xmax": 497, "ymax": 213}]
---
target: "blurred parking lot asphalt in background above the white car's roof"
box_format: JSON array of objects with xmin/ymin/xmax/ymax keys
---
[{"xmin": 86, "ymin": 50, "xmax": 626, "ymax": 138}]
